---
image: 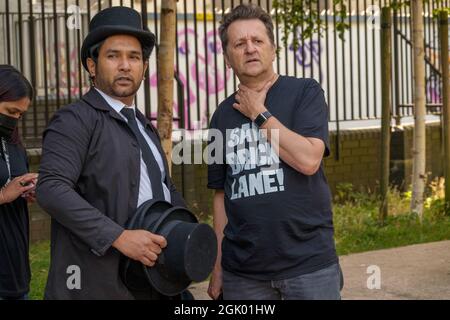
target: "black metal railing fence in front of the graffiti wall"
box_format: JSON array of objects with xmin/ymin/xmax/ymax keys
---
[{"xmin": 0, "ymin": 0, "xmax": 450, "ymax": 146}]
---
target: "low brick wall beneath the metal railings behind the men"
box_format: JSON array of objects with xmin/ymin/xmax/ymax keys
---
[{"xmin": 28, "ymin": 123, "xmax": 443, "ymax": 241}]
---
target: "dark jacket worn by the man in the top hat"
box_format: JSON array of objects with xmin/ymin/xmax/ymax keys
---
[{"xmin": 37, "ymin": 88, "xmax": 184, "ymax": 299}]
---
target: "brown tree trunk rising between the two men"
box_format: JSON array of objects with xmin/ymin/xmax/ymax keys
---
[{"xmin": 158, "ymin": 0, "xmax": 177, "ymax": 174}]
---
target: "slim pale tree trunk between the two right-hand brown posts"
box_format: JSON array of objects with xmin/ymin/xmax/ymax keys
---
[{"xmin": 411, "ymin": 0, "xmax": 427, "ymax": 220}]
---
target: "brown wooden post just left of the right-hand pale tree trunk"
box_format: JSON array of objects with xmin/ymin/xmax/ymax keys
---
[{"xmin": 379, "ymin": 7, "xmax": 391, "ymax": 224}]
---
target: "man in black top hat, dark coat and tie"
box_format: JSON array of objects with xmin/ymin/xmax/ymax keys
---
[{"xmin": 37, "ymin": 7, "xmax": 184, "ymax": 299}]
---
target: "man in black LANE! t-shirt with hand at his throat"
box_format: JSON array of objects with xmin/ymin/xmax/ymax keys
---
[{"xmin": 208, "ymin": 4, "xmax": 342, "ymax": 300}]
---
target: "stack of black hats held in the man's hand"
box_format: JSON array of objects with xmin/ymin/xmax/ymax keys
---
[{"xmin": 120, "ymin": 200, "xmax": 217, "ymax": 297}]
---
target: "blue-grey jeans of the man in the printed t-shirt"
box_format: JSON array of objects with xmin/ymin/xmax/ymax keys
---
[{"xmin": 223, "ymin": 263, "xmax": 343, "ymax": 300}]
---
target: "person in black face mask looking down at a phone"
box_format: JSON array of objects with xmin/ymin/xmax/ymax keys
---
[{"xmin": 0, "ymin": 65, "xmax": 37, "ymax": 300}]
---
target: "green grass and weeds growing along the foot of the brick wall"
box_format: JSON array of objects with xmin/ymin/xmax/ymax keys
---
[{"xmin": 30, "ymin": 181, "xmax": 450, "ymax": 299}]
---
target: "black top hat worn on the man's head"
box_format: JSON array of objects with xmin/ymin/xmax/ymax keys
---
[{"xmin": 81, "ymin": 7, "xmax": 156, "ymax": 71}]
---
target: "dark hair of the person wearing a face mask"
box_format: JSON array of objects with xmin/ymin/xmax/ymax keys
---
[{"xmin": 0, "ymin": 64, "xmax": 33, "ymax": 144}]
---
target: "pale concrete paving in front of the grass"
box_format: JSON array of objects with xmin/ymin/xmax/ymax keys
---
[{"xmin": 190, "ymin": 241, "xmax": 450, "ymax": 300}]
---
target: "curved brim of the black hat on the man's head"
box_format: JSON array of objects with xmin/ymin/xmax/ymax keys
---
[{"xmin": 81, "ymin": 26, "xmax": 156, "ymax": 71}]
